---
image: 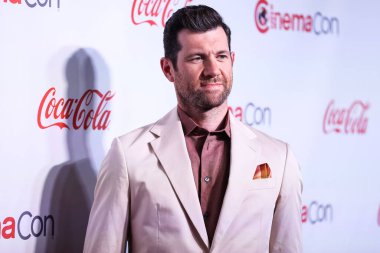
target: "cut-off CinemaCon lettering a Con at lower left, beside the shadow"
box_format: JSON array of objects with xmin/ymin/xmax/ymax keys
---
[{"xmin": 0, "ymin": 211, "xmax": 54, "ymax": 240}]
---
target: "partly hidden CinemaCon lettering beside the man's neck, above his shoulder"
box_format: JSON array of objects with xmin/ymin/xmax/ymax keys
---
[{"xmin": 228, "ymin": 102, "xmax": 272, "ymax": 126}]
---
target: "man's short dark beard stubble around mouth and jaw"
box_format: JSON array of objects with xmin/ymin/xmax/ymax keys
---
[{"xmin": 175, "ymin": 74, "xmax": 232, "ymax": 111}]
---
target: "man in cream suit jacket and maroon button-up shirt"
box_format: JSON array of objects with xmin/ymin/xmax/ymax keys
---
[{"xmin": 84, "ymin": 6, "xmax": 302, "ymax": 253}]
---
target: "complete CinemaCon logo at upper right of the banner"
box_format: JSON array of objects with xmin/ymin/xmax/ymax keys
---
[{"xmin": 254, "ymin": 0, "xmax": 339, "ymax": 35}]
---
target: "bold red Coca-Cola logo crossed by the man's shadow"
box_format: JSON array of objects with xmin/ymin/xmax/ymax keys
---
[{"xmin": 37, "ymin": 87, "xmax": 115, "ymax": 130}]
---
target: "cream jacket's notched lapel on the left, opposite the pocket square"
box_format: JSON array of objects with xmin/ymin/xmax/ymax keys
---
[{"xmin": 151, "ymin": 108, "xmax": 208, "ymax": 248}]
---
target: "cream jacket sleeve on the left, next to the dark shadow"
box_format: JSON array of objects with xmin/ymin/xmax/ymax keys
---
[{"xmin": 83, "ymin": 138, "xmax": 129, "ymax": 253}]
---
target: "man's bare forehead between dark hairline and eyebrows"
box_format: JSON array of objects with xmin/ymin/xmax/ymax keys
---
[{"xmin": 178, "ymin": 26, "xmax": 229, "ymax": 51}]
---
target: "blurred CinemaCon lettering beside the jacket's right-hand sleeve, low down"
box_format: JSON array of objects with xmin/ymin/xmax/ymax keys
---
[{"xmin": 301, "ymin": 201, "xmax": 333, "ymax": 225}]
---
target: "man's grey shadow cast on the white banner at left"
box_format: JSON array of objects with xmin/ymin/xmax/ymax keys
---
[{"xmin": 35, "ymin": 49, "xmax": 109, "ymax": 253}]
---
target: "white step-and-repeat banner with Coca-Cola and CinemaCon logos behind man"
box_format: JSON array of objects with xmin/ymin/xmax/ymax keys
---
[{"xmin": 0, "ymin": 0, "xmax": 380, "ymax": 253}]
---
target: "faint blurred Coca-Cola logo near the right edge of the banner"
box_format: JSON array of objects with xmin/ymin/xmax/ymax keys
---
[{"xmin": 323, "ymin": 100, "xmax": 369, "ymax": 134}]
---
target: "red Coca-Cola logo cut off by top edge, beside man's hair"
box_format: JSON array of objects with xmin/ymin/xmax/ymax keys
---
[{"xmin": 131, "ymin": 0, "xmax": 192, "ymax": 27}]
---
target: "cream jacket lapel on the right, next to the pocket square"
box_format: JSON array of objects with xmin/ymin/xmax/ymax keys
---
[{"xmin": 211, "ymin": 115, "xmax": 260, "ymax": 252}]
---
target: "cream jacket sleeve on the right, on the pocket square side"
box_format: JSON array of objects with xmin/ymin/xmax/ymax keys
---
[{"xmin": 269, "ymin": 145, "xmax": 303, "ymax": 253}]
